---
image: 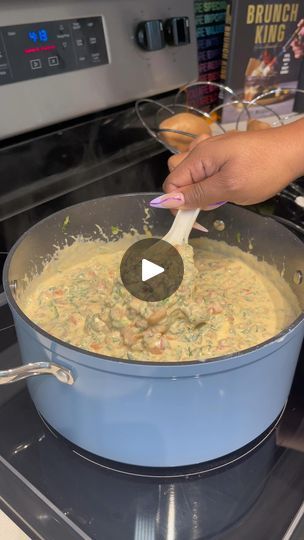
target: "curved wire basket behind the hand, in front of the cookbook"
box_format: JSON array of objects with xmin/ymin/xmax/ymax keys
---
[{"xmin": 135, "ymin": 81, "xmax": 304, "ymax": 154}]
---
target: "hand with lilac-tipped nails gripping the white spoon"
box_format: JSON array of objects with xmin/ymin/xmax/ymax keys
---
[{"xmin": 150, "ymin": 120, "xmax": 304, "ymax": 210}]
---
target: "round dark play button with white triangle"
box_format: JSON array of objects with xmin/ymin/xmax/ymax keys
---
[{"xmin": 120, "ymin": 238, "xmax": 184, "ymax": 302}]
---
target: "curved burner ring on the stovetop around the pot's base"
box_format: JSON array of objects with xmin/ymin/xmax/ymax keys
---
[{"xmin": 38, "ymin": 405, "xmax": 286, "ymax": 479}]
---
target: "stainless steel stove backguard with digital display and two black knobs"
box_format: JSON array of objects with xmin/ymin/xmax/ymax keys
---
[{"xmin": 0, "ymin": 0, "xmax": 198, "ymax": 141}]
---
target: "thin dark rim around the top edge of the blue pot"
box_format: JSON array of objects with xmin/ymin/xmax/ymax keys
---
[{"xmin": 3, "ymin": 192, "xmax": 304, "ymax": 367}]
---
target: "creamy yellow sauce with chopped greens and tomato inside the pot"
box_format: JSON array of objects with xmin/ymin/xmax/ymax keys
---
[{"xmin": 20, "ymin": 239, "xmax": 300, "ymax": 362}]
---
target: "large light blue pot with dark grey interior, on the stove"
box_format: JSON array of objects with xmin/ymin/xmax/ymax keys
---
[{"xmin": 0, "ymin": 194, "xmax": 304, "ymax": 467}]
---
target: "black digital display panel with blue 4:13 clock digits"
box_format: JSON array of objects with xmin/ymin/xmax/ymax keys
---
[{"xmin": 0, "ymin": 17, "xmax": 109, "ymax": 85}]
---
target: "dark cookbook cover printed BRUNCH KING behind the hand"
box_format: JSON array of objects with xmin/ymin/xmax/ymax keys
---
[{"xmin": 221, "ymin": 0, "xmax": 304, "ymax": 122}]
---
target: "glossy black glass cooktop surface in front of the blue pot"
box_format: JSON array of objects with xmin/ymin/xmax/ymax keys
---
[{"xmin": 0, "ymin": 306, "xmax": 304, "ymax": 540}]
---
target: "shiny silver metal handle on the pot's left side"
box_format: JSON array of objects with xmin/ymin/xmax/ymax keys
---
[{"xmin": 0, "ymin": 362, "xmax": 75, "ymax": 385}]
